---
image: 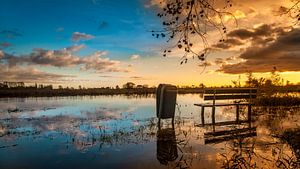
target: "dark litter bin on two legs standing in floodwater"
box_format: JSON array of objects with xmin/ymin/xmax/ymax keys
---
[{"xmin": 156, "ymin": 84, "xmax": 177, "ymax": 125}]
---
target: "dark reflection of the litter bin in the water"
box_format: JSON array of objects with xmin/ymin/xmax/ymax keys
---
[{"xmin": 156, "ymin": 128, "xmax": 178, "ymax": 165}]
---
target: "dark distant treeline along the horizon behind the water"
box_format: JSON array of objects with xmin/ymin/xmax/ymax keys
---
[{"xmin": 0, "ymin": 85, "xmax": 300, "ymax": 97}]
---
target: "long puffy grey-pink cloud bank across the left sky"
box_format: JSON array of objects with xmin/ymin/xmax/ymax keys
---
[{"xmin": 1, "ymin": 45, "xmax": 129, "ymax": 72}]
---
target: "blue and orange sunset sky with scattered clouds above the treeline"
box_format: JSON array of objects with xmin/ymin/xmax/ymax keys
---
[{"xmin": 0, "ymin": 0, "xmax": 300, "ymax": 87}]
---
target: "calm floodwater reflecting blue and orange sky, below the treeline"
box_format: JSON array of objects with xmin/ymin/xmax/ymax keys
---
[{"xmin": 0, "ymin": 95, "xmax": 300, "ymax": 169}]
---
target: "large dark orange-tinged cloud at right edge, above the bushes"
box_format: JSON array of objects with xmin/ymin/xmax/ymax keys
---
[{"xmin": 219, "ymin": 29, "xmax": 300, "ymax": 74}]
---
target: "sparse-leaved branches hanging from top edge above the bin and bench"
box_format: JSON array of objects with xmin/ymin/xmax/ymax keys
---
[{"xmin": 152, "ymin": 0, "xmax": 237, "ymax": 64}]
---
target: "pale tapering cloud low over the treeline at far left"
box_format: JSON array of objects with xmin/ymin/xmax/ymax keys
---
[{"xmin": 0, "ymin": 64, "xmax": 74, "ymax": 82}]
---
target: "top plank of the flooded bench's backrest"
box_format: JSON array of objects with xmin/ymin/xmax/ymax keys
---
[{"xmin": 204, "ymin": 88, "xmax": 257, "ymax": 94}]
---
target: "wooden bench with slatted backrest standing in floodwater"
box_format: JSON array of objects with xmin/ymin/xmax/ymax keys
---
[{"xmin": 195, "ymin": 88, "xmax": 257, "ymax": 125}]
